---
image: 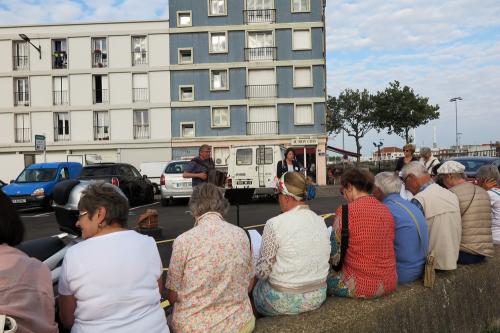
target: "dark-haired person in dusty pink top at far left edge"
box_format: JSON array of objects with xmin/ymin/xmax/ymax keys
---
[{"xmin": 0, "ymin": 190, "xmax": 58, "ymax": 333}]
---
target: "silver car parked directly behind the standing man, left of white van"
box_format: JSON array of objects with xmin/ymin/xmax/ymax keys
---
[{"xmin": 160, "ymin": 160, "xmax": 193, "ymax": 206}]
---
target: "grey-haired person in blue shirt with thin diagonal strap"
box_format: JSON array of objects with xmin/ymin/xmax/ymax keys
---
[{"xmin": 373, "ymin": 172, "xmax": 429, "ymax": 284}]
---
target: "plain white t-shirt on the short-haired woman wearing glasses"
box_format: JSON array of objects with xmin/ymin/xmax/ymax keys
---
[{"xmin": 59, "ymin": 230, "xmax": 169, "ymax": 333}]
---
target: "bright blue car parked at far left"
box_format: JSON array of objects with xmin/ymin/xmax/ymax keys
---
[{"xmin": 2, "ymin": 162, "xmax": 82, "ymax": 209}]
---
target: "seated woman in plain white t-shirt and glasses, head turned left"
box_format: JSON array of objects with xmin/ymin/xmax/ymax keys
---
[{"xmin": 59, "ymin": 183, "xmax": 169, "ymax": 333}]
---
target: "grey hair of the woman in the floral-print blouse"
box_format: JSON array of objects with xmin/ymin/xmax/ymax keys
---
[{"xmin": 189, "ymin": 183, "xmax": 229, "ymax": 217}]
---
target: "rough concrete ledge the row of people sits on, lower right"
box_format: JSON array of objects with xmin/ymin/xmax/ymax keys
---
[{"xmin": 254, "ymin": 246, "xmax": 500, "ymax": 333}]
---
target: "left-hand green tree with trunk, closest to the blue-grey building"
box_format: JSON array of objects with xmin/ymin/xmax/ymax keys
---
[{"xmin": 327, "ymin": 89, "xmax": 375, "ymax": 163}]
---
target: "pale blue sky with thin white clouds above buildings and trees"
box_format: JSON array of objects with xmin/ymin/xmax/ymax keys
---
[{"xmin": 0, "ymin": 0, "xmax": 500, "ymax": 154}]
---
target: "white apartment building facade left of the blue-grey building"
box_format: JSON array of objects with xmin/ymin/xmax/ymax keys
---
[{"xmin": 0, "ymin": 20, "xmax": 171, "ymax": 180}]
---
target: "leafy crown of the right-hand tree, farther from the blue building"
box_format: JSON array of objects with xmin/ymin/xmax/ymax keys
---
[{"xmin": 373, "ymin": 81, "xmax": 439, "ymax": 143}]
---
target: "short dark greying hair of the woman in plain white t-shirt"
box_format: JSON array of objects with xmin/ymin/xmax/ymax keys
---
[{"xmin": 78, "ymin": 182, "xmax": 129, "ymax": 227}]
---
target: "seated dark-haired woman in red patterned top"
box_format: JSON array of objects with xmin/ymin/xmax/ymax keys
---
[{"xmin": 328, "ymin": 168, "xmax": 398, "ymax": 298}]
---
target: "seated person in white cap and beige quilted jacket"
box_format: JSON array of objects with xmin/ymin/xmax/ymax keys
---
[{"xmin": 437, "ymin": 161, "xmax": 493, "ymax": 265}]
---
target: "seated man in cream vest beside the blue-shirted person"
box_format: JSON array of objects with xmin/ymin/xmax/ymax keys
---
[{"xmin": 401, "ymin": 162, "xmax": 462, "ymax": 270}]
